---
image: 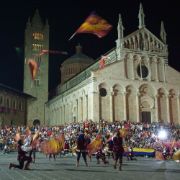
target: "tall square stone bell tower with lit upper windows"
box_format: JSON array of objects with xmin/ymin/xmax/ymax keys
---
[{"xmin": 23, "ymin": 9, "xmax": 49, "ymax": 125}]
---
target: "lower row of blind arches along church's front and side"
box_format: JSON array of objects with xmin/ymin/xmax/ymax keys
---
[{"xmin": 48, "ymin": 83, "xmax": 179, "ymax": 124}]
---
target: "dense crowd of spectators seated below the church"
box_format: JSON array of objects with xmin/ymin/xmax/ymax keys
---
[{"xmin": 0, "ymin": 120, "xmax": 180, "ymax": 153}]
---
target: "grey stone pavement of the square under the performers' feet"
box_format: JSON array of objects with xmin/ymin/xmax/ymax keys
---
[{"xmin": 0, "ymin": 152, "xmax": 180, "ymax": 180}]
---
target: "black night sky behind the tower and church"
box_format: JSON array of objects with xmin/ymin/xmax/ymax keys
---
[{"xmin": 0, "ymin": 0, "xmax": 180, "ymax": 90}]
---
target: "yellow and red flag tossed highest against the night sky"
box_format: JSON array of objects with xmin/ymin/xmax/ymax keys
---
[{"xmin": 69, "ymin": 13, "xmax": 112, "ymax": 40}]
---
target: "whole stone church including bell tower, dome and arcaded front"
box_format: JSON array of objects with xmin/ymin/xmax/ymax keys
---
[{"xmin": 24, "ymin": 4, "xmax": 180, "ymax": 125}]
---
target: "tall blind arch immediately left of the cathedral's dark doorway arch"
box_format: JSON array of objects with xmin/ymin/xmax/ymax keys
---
[{"xmin": 126, "ymin": 85, "xmax": 137, "ymax": 121}]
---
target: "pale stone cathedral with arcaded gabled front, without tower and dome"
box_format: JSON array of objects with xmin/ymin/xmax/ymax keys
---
[{"xmin": 46, "ymin": 5, "xmax": 180, "ymax": 125}]
